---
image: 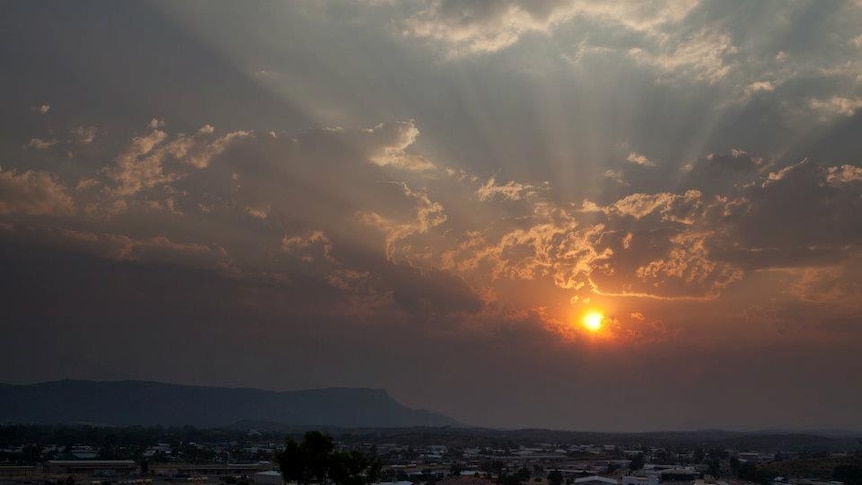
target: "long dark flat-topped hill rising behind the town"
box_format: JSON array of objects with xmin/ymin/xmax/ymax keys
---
[{"xmin": 0, "ymin": 380, "xmax": 460, "ymax": 427}]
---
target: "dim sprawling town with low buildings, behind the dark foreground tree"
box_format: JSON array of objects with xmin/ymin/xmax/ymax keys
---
[{"xmin": 0, "ymin": 425, "xmax": 862, "ymax": 485}]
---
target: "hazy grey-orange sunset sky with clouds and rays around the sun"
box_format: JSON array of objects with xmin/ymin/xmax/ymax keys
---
[{"xmin": 0, "ymin": 0, "xmax": 862, "ymax": 430}]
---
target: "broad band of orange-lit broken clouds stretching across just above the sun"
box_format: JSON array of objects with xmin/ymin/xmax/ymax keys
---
[{"xmin": 4, "ymin": 114, "xmax": 862, "ymax": 321}]
